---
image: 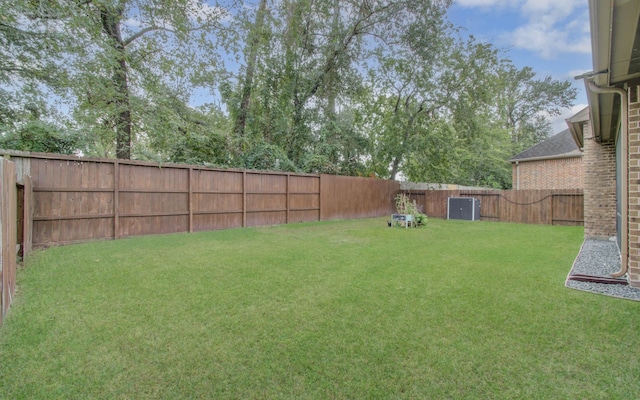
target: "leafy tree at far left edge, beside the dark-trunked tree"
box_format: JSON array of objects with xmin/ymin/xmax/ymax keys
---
[{"xmin": 0, "ymin": 1, "xmax": 75, "ymax": 145}]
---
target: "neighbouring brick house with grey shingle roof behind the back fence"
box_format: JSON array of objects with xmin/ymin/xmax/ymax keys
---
[{"xmin": 509, "ymin": 129, "xmax": 584, "ymax": 190}]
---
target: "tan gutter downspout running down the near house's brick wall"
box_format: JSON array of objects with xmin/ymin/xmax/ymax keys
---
[{"xmin": 585, "ymin": 76, "xmax": 629, "ymax": 278}]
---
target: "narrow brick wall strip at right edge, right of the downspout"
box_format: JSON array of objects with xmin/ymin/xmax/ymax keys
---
[{"xmin": 628, "ymin": 87, "xmax": 640, "ymax": 287}]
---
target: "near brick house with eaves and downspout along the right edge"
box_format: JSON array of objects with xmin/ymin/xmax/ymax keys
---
[{"xmin": 567, "ymin": 0, "xmax": 640, "ymax": 288}]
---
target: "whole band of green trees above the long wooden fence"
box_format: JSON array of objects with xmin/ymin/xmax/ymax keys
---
[{"xmin": 0, "ymin": 0, "xmax": 575, "ymax": 188}]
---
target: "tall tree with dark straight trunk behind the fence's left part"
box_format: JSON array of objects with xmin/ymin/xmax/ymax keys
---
[{"xmin": 39, "ymin": 0, "xmax": 232, "ymax": 159}]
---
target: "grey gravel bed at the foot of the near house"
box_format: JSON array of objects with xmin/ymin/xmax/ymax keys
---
[{"xmin": 565, "ymin": 238, "xmax": 640, "ymax": 301}]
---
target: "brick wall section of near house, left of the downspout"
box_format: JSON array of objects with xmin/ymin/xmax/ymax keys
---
[{"xmin": 582, "ymin": 122, "xmax": 616, "ymax": 238}]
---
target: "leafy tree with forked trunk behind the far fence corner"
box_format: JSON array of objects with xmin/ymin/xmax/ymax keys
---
[{"xmin": 362, "ymin": 21, "xmax": 472, "ymax": 179}]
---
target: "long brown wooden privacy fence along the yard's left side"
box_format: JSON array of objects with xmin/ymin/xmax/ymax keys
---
[{"xmin": 0, "ymin": 151, "xmax": 399, "ymax": 247}]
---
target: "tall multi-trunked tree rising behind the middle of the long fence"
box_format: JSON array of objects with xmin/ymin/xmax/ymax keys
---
[{"xmin": 228, "ymin": 0, "xmax": 449, "ymax": 167}]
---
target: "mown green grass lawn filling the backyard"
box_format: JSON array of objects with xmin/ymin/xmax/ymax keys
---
[{"xmin": 0, "ymin": 219, "xmax": 640, "ymax": 399}]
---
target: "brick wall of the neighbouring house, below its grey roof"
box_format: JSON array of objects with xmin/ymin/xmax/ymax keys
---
[{"xmin": 512, "ymin": 157, "xmax": 584, "ymax": 190}]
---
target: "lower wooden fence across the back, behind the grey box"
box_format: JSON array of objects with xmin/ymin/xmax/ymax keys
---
[{"xmin": 405, "ymin": 189, "xmax": 584, "ymax": 226}]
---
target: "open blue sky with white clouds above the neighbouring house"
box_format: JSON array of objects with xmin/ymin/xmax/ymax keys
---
[{"xmin": 448, "ymin": 0, "xmax": 592, "ymax": 133}]
